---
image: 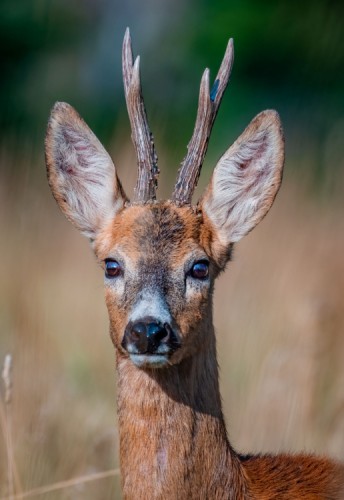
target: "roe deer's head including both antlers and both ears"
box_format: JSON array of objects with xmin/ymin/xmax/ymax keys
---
[{"xmin": 46, "ymin": 30, "xmax": 284, "ymax": 369}]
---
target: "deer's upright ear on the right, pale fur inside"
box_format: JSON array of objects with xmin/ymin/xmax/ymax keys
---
[{"xmin": 200, "ymin": 110, "xmax": 284, "ymax": 254}]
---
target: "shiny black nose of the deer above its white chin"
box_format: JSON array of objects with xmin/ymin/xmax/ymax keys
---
[{"xmin": 122, "ymin": 317, "xmax": 172, "ymax": 354}]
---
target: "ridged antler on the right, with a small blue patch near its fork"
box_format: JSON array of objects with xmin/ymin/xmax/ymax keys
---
[{"xmin": 172, "ymin": 38, "xmax": 234, "ymax": 204}]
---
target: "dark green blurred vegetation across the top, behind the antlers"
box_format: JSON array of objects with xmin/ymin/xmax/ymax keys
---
[{"xmin": 0, "ymin": 0, "xmax": 344, "ymax": 184}]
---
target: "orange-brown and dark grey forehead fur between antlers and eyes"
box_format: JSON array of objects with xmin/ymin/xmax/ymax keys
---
[{"xmin": 94, "ymin": 200, "xmax": 218, "ymax": 260}]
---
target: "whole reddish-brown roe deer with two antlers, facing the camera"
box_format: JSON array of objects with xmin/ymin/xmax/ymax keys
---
[{"xmin": 46, "ymin": 30, "xmax": 344, "ymax": 500}]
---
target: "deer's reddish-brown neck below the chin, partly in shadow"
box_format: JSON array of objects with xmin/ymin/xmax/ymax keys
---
[{"xmin": 117, "ymin": 327, "xmax": 247, "ymax": 499}]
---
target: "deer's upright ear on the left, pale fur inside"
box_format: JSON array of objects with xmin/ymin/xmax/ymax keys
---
[{"xmin": 45, "ymin": 102, "xmax": 126, "ymax": 240}]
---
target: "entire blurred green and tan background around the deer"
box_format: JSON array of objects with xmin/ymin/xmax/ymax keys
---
[{"xmin": 0, "ymin": 0, "xmax": 344, "ymax": 500}]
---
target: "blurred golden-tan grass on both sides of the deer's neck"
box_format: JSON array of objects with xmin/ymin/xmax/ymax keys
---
[{"xmin": 0, "ymin": 149, "xmax": 344, "ymax": 500}]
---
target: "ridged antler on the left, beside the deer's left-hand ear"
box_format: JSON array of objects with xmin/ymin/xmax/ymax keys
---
[{"xmin": 122, "ymin": 28, "xmax": 159, "ymax": 202}]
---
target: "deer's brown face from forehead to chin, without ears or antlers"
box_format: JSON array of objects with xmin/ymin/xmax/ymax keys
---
[{"xmin": 95, "ymin": 202, "xmax": 218, "ymax": 367}]
